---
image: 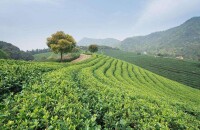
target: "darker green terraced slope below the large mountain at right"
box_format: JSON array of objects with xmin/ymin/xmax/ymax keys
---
[{"xmin": 101, "ymin": 50, "xmax": 200, "ymax": 89}]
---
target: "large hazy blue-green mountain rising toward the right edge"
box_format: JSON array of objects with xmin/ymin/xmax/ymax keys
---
[{"xmin": 120, "ymin": 17, "xmax": 200, "ymax": 59}]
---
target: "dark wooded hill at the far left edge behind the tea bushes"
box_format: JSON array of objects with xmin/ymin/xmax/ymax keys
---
[{"xmin": 0, "ymin": 41, "xmax": 34, "ymax": 60}]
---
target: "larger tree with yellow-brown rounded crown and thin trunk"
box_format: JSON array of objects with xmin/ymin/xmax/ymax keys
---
[{"xmin": 47, "ymin": 31, "xmax": 76, "ymax": 61}]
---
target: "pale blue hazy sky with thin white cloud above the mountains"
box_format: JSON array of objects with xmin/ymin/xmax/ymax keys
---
[{"xmin": 0, "ymin": 0, "xmax": 200, "ymax": 50}]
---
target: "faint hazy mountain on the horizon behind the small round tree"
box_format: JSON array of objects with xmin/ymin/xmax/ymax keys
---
[{"xmin": 77, "ymin": 38, "xmax": 120, "ymax": 47}]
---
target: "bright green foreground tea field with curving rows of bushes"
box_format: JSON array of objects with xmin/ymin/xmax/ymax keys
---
[{"xmin": 0, "ymin": 55, "xmax": 200, "ymax": 130}]
